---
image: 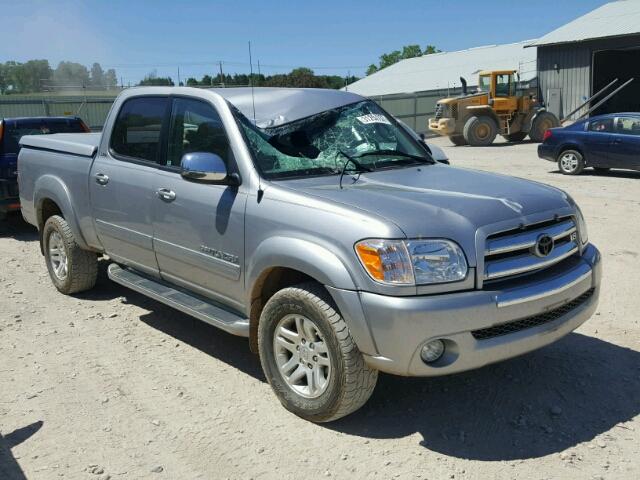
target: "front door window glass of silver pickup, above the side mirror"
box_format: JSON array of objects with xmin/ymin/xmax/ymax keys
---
[{"xmin": 167, "ymin": 98, "xmax": 231, "ymax": 166}]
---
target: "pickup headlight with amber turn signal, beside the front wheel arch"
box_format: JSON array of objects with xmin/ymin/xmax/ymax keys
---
[{"xmin": 355, "ymin": 239, "xmax": 468, "ymax": 285}]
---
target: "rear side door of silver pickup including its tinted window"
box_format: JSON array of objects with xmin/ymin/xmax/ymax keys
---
[{"xmin": 89, "ymin": 96, "xmax": 169, "ymax": 276}]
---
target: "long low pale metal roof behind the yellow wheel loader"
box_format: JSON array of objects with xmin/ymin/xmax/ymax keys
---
[{"xmin": 348, "ymin": 40, "xmax": 536, "ymax": 97}]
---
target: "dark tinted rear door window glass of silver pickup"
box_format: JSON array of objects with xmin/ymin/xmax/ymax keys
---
[{"xmin": 110, "ymin": 97, "xmax": 169, "ymax": 163}]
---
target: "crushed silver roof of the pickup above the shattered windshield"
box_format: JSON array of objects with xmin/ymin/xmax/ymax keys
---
[{"xmin": 208, "ymin": 87, "xmax": 364, "ymax": 128}]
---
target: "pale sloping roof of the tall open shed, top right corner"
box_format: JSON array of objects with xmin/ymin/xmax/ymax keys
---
[{"xmin": 531, "ymin": 0, "xmax": 640, "ymax": 46}]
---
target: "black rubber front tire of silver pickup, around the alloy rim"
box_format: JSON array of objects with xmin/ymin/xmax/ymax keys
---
[{"xmin": 258, "ymin": 282, "xmax": 378, "ymax": 422}]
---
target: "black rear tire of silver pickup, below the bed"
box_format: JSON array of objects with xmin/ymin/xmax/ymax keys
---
[{"xmin": 42, "ymin": 215, "xmax": 98, "ymax": 295}]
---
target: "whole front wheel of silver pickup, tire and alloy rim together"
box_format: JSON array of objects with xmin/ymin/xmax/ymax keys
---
[{"xmin": 258, "ymin": 283, "xmax": 378, "ymax": 422}]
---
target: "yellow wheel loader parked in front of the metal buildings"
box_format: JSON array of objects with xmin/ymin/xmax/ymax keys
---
[{"xmin": 429, "ymin": 70, "xmax": 560, "ymax": 146}]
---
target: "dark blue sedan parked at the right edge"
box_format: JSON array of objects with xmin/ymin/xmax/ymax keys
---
[{"xmin": 538, "ymin": 113, "xmax": 640, "ymax": 175}]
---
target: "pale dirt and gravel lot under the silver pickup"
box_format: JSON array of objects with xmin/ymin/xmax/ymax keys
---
[{"xmin": 0, "ymin": 136, "xmax": 640, "ymax": 480}]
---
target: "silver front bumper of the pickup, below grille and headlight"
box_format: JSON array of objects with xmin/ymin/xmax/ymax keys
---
[{"xmin": 330, "ymin": 244, "xmax": 601, "ymax": 376}]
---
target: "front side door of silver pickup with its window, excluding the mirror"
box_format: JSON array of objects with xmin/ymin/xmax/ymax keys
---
[{"xmin": 153, "ymin": 97, "xmax": 246, "ymax": 308}]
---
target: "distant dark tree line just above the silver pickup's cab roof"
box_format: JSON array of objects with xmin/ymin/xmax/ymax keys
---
[{"xmin": 139, "ymin": 67, "xmax": 359, "ymax": 89}]
